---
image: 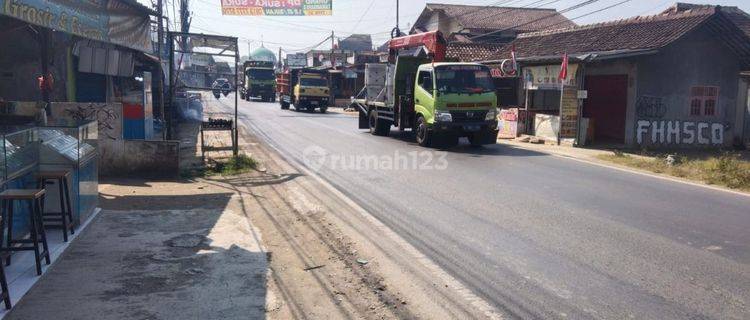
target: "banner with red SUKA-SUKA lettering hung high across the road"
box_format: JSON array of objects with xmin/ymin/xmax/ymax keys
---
[{"xmin": 221, "ymin": 0, "xmax": 333, "ymax": 16}]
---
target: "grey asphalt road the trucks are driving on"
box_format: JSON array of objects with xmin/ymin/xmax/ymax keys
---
[{"xmin": 214, "ymin": 101, "xmax": 750, "ymax": 319}]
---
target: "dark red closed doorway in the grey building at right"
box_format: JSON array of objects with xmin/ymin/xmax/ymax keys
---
[{"xmin": 583, "ymin": 75, "xmax": 628, "ymax": 144}]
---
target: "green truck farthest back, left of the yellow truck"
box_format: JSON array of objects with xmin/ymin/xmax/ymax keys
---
[{"xmin": 240, "ymin": 61, "xmax": 276, "ymax": 102}]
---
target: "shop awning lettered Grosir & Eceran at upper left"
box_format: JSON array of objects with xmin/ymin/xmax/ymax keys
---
[{"xmin": 0, "ymin": 0, "xmax": 153, "ymax": 53}]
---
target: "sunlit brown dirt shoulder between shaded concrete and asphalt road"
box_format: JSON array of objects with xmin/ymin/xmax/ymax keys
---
[{"xmin": 191, "ymin": 104, "xmax": 499, "ymax": 319}]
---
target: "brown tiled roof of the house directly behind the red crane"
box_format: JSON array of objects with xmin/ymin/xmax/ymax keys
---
[{"xmin": 420, "ymin": 3, "xmax": 575, "ymax": 32}]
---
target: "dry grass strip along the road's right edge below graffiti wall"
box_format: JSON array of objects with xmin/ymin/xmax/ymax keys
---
[{"xmin": 599, "ymin": 151, "xmax": 750, "ymax": 191}]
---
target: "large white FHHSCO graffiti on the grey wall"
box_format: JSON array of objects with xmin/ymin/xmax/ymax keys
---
[{"xmin": 636, "ymin": 120, "xmax": 725, "ymax": 146}]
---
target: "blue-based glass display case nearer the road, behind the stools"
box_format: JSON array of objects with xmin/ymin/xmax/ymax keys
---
[{"xmin": 38, "ymin": 121, "xmax": 99, "ymax": 221}]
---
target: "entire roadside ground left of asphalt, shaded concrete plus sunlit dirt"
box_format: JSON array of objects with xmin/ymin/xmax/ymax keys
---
[{"xmin": 8, "ymin": 102, "xmax": 500, "ymax": 319}]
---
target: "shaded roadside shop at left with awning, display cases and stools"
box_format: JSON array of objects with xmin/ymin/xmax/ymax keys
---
[{"xmin": 0, "ymin": 0, "xmax": 159, "ymax": 315}]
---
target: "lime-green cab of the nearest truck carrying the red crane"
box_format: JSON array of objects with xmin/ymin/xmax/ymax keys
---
[{"xmin": 413, "ymin": 62, "xmax": 498, "ymax": 146}]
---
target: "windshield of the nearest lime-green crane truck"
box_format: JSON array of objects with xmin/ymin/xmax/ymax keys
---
[{"xmin": 435, "ymin": 66, "xmax": 495, "ymax": 93}]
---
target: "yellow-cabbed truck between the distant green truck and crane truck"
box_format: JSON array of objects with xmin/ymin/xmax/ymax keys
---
[{"xmin": 276, "ymin": 68, "xmax": 330, "ymax": 113}]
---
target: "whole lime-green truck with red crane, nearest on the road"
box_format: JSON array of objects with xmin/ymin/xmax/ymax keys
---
[{"xmin": 352, "ymin": 32, "xmax": 498, "ymax": 147}]
